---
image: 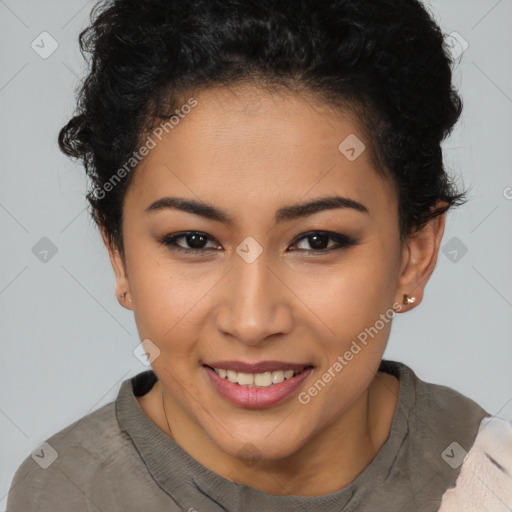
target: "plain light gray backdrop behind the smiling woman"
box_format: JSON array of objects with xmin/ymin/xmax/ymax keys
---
[{"xmin": 0, "ymin": 0, "xmax": 512, "ymax": 510}]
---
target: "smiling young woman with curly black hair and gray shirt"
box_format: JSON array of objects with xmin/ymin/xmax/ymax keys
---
[{"xmin": 8, "ymin": 0, "xmax": 512, "ymax": 512}]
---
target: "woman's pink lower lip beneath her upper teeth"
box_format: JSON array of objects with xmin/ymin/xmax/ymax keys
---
[{"xmin": 203, "ymin": 366, "xmax": 313, "ymax": 409}]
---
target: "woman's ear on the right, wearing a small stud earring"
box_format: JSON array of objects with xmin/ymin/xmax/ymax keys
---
[{"xmin": 395, "ymin": 203, "xmax": 447, "ymax": 312}]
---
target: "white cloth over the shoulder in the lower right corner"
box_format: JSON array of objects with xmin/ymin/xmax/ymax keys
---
[{"xmin": 439, "ymin": 418, "xmax": 512, "ymax": 512}]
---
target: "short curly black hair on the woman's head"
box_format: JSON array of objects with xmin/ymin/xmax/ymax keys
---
[{"xmin": 59, "ymin": 0, "xmax": 465, "ymax": 256}]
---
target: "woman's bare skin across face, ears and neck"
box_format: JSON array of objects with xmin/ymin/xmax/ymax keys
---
[{"xmin": 102, "ymin": 85, "xmax": 445, "ymax": 496}]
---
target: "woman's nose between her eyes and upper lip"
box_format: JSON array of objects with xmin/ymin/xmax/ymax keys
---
[{"xmin": 216, "ymin": 246, "xmax": 293, "ymax": 346}]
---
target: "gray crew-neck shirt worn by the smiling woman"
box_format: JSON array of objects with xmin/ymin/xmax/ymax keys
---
[{"xmin": 7, "ymin": 360, "xmax": 490, "ymax": 512}]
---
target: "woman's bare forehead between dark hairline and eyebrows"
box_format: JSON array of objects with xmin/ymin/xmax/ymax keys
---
[{"xmin": 126, "ymin": 85, "xmax": 396, "ymax": 224}]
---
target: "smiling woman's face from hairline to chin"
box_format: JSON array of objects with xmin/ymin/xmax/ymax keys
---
[{"xmin": 109, "ymin": 86, "xmax": 428, "ymax": 459}]
